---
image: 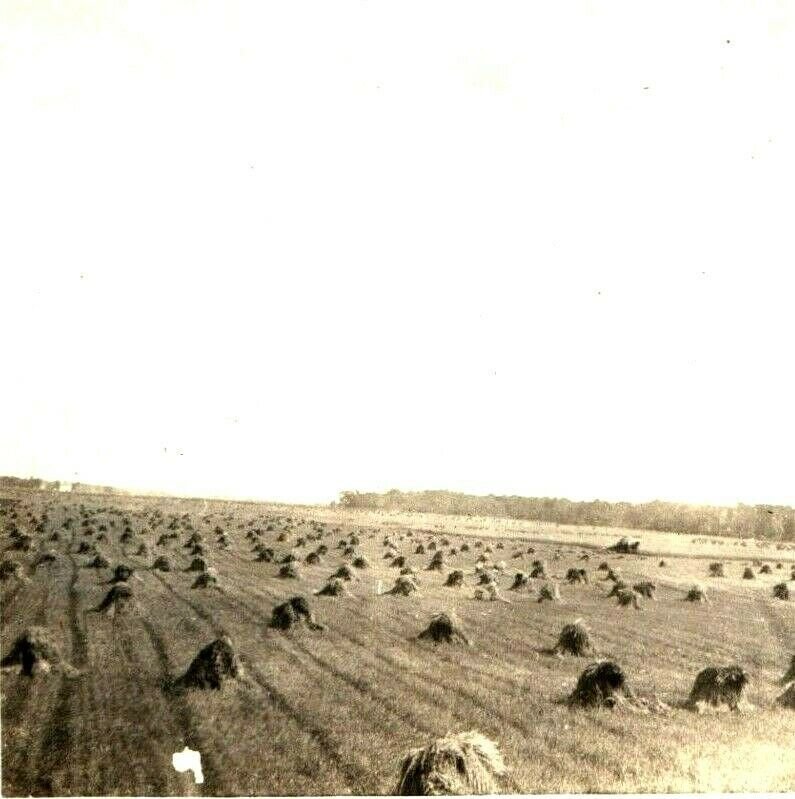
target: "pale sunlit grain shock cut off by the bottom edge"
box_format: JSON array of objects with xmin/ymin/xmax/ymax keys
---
[{"xmin": 392, "ymin": 730, "xmax": 507, "ymax": 796}]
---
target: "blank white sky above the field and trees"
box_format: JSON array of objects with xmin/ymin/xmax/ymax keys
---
[{"xmin": 0, "ymin": 0, "xmax": 795, "ymax": 505}]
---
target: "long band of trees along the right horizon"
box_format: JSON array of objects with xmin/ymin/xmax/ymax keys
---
[{"xmin": 340, "ymin": 490, "xmax": 795, "ymax": 541}]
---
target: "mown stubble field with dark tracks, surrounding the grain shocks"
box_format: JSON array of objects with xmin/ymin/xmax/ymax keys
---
[{"xmin": 0, "ymin": 492, "xmax": 795, "ymax": 796}]
